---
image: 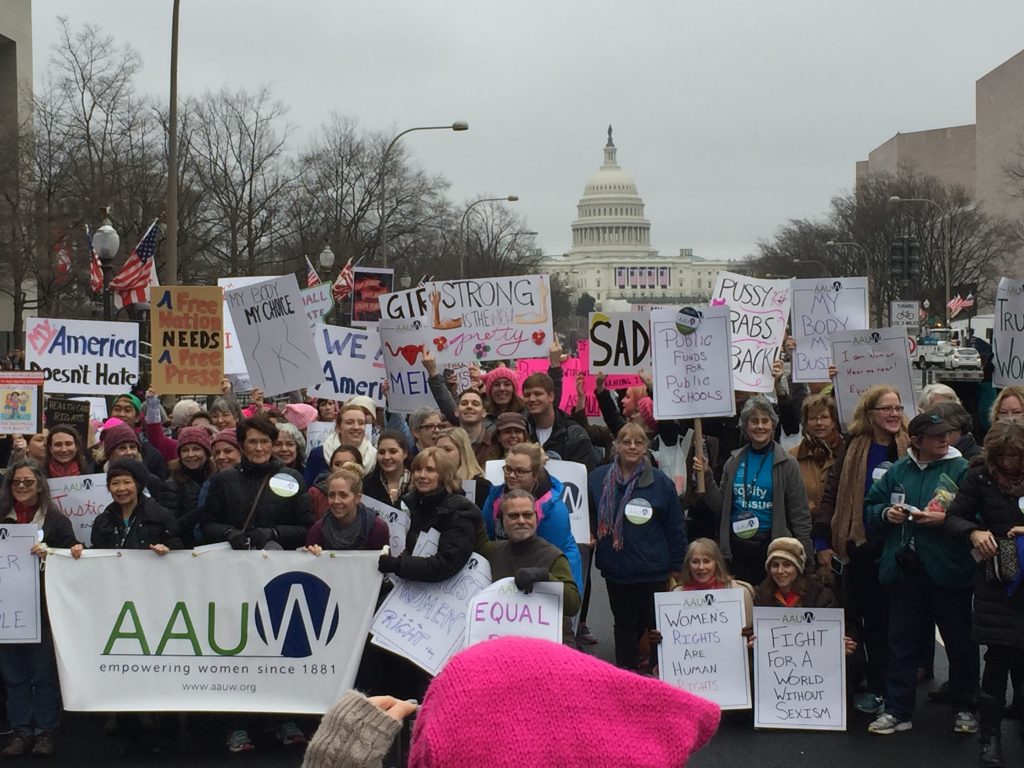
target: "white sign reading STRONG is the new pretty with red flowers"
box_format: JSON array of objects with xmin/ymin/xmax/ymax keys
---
[{"xmin": 421, "ymin": 274, "xmax": 554, "ymax": 365}]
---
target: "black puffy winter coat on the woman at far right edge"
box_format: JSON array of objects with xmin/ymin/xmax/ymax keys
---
[{"xmin": 945, "ymin": 464, "xmax": 1024, "ymax": 649}]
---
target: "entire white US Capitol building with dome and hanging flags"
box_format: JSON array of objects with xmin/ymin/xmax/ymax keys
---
[{"xmin": 541, "ymin": 125, "xmax": 745, "ymax": 311}]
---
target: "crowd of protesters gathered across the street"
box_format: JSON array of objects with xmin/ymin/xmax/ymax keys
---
[{"xmin": 0, "ymin": 344, "xmax": 1024, "ymax": 766}]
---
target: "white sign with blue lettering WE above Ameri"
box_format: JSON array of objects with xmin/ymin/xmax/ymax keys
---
[{"xmin": 310, "ymin": 325, "xmax": 387, "ymax": 408}]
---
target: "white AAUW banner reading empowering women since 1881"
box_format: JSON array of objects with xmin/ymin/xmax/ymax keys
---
[{"xmin": 46, "ymin": 550, "xmax": 381, "ymax": 714}]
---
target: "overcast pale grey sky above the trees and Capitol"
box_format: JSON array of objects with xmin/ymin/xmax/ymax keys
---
[{"xmin": 25, "ymin": 0, "xmax": 1024, "ymax": 258}]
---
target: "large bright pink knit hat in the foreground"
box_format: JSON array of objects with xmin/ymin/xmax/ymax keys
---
[{"xmin": 409, "ymin": 637, "xmax": 719, "ymax": 768}]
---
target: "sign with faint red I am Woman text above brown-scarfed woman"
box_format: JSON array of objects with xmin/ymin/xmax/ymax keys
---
[{"xmin": 831, "ymin": 328, "xmax": 918, "ymax": 424}]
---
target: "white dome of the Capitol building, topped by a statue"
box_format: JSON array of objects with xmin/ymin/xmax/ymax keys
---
[{"xmin": 569, "ymin": 125, "xmax": 650, "ymax": 254}]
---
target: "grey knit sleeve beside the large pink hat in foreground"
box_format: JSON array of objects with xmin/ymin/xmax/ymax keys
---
[{"xmin": 302, "ymin": 690, "xmax": 401, "ymax": 768}]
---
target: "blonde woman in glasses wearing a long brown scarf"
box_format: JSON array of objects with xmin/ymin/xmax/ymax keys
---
[{"xmin": 813, "ymin": 384, "xmax": 910, "ymax": 715}]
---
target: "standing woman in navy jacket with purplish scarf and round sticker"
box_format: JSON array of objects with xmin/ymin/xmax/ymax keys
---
[{"xmin": 589, "ymin": 422, "xmax": 686, "ymax": 670}]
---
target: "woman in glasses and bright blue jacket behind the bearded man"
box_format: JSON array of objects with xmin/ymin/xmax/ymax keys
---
[{"xmin": 482, "ymin": 442, "xmax": 584, "ymax": 593}]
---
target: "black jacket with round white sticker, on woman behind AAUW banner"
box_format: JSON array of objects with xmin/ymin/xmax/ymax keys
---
[{"xmin": 199, "ymin": 459, "xmax": 313, "ymax": 549}]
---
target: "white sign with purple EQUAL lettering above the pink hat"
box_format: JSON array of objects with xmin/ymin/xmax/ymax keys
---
[{"xmin": 466, "ymin": 577, "xmax": 565, "ymax": 648}]
